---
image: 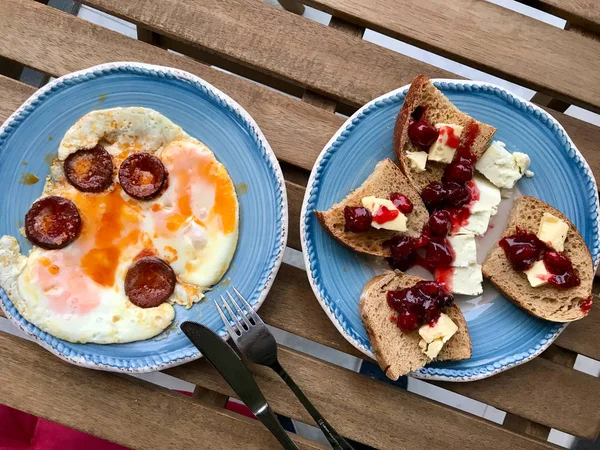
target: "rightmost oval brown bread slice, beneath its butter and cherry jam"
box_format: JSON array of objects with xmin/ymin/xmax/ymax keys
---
[{"xmin": 482, "ymin": 196, "xmax": 594, "ymax": 322}]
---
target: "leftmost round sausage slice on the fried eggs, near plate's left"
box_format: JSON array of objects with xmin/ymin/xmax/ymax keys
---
[{"xmin": 25, "ymin": 196, "xmax": 81, "ymax": 250}]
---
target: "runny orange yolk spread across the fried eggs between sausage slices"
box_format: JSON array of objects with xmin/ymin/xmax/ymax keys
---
[{"xmin": 37, "ymin": 141, "xmax": 237, "ymax": 313}]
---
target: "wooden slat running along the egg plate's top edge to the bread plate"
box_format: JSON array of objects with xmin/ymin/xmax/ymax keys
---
[{"xmin": 0, "ymin": 0, "xmax": 343, "ymax": 169}]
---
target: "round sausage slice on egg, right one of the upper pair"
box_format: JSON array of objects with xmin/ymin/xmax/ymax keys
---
[{"xmin": 119, "ymin": 153, "xmax": 167, "ymax": 200}]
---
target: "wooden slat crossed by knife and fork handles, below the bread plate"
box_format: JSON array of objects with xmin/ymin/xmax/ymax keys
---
[{"xmin": 167, "ymin": 347, "xmax": 546, "ymax": 449}]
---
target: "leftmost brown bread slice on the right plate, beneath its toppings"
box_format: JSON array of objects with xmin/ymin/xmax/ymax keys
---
[{"xmin": 315, "ymin": 159, "xmax": 429, "ymax": 256}]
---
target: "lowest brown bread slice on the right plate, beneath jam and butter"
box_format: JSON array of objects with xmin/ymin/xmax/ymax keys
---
[{"xmin": 360, "ymin": 271, "xmax": 471, "ymax": 380}]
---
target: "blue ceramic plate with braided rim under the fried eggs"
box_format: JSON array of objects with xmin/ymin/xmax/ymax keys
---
[{"xmin": 0, "ymin": 63, "xmax": 287, "ymax": 372}]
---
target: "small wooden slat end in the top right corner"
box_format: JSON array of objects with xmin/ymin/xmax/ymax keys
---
[{"xmin": 517, "ymin": 0, "xmax": 600, "ymax": 32}]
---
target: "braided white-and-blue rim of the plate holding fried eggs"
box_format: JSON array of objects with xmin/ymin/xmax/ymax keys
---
[{"xmin": 0, "ymin": 61, "xmax": 289, "ymax": 373}]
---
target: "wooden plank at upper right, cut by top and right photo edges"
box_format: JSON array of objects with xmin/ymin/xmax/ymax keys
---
[{"xmin": 306, "ymin": 0, "xmax": 600, "ymax": 111}]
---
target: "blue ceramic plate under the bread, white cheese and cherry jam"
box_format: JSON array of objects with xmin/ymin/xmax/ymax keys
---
[{"xmin": 300, "ymin": 80, "xmax": 600, "ymax": 381}]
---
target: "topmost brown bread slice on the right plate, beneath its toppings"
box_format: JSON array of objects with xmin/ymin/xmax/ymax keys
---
[{"xmin": 394, "ymin": 75, "xmax": 496, "ymax": 192}]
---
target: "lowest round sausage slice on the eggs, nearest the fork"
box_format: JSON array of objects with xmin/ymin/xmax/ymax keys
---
[{"xmin": 125, "ymin": 256, "xmax": 175, "ymax": 308}]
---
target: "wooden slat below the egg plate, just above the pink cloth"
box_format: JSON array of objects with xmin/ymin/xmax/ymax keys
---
[{"xmin": 0, "ymin": 333, "xmax": 324, "ymax": 450}]
